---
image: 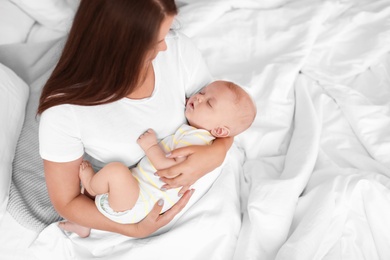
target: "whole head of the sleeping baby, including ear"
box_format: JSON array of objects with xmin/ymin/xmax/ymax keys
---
[{"xmin": 185, "ymin": 81, "xmax": 256, "ymax": 137}]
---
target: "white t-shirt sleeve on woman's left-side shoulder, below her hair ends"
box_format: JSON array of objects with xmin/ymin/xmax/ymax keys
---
[{"xmin": 39, "ymin": 105, "xmax": 84, "ymax": 162}]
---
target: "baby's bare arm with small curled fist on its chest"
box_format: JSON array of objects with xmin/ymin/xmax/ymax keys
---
[{"xmin": 137, "ymin": 129, "xmax": 185, "ymax": 170}]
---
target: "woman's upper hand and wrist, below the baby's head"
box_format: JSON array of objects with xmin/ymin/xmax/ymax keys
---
[{"xmin": 156, "ymin": 137, "xmax": 234, "ymax": 189}]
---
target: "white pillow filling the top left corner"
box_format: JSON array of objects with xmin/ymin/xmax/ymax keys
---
[{"xmin": 0, "ymin": 0, "xmax": 35, "ymax": 44}]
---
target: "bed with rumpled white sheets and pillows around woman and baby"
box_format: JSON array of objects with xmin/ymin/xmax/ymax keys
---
[{"xmin": 0, "ymin": 0, "xmax": 390, "ymax": 260}]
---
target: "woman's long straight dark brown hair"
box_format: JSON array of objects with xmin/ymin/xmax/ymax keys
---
[{"xmin": 37, "ymin": 0, "xmax": 177, "ymax": 114}]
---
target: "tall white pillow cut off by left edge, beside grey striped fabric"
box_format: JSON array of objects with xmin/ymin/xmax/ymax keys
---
[{"xmin": 0, "ymin": 63, "xmax": 29, "ymax": 219}]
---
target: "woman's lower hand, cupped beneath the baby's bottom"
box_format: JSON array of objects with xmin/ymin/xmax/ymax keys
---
[{"xmin": 133, "ymin": 189, "xmax": 195, "ymax": 238}]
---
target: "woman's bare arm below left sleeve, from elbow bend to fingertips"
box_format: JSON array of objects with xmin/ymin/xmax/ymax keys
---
[{"xmin": 44, "ymin": 158, "xmax": 193, "ymax": 237}]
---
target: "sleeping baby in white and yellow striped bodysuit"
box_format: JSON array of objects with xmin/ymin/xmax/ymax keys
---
[{"xmin": 60, "ymin": 81, "xmax": 256, "ymax": 237}]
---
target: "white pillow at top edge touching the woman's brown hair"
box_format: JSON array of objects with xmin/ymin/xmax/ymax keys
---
[{"xmin": 10, "ymin": 0, "xmax": 76, "ymax": 32}]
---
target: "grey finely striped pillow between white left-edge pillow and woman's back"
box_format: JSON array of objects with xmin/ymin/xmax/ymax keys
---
[{"xmin": 0, "ymin": 38, "xmax": 65, "ymax": 230}]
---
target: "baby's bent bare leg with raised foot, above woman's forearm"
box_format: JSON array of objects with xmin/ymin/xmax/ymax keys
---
[{"xmin": 80, "ymin": 161, "xmax": 139, "ymax": 212}]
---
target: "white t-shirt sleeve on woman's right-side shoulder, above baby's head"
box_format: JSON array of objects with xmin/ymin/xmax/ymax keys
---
[{"xmin": 179, "ymin": 33, "xmax": 212, "ymax": 97}]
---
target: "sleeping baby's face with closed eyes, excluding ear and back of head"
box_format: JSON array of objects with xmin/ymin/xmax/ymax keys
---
[{"xmin": 185, "ymin": 82, "xmax": 237, "ymax": 131}]
